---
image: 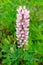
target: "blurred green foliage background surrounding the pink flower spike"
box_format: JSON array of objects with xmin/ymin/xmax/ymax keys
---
[{"xmin": 0, "ymin": 0, "xmax": 43, "ymax": 65}]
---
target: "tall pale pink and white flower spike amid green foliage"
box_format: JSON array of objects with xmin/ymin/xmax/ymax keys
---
[{"xmin": 16, "ymin": 6, "xmax": 30, "ymax": 47}]
